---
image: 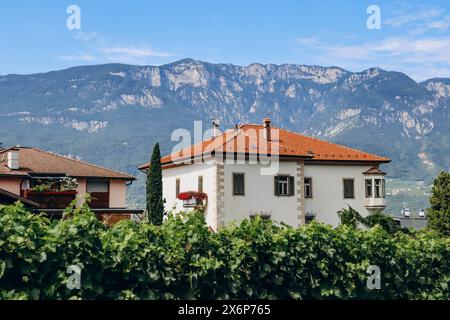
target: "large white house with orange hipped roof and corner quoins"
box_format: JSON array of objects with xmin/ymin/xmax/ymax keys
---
[{"xmin": 140, "ymin": 119, "xmax": 390, "ymax": 230}]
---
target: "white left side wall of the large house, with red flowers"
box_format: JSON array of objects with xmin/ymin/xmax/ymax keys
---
[{"xmin": 163, "ymin": 161, "xmax": 217, "ymax": 230}]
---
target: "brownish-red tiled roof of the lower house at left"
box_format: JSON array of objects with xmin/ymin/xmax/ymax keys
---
[{"xmin": 0, "ymin": 147, "xmax": 135, "ymax": 181}]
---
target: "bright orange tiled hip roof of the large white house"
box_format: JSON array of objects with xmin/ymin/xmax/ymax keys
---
[{"xmin": 139, "ymin": 124, "xmax": 390, "ymax": 170}]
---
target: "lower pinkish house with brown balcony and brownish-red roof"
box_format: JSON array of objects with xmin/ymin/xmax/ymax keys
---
[{"xmin": 0, "ymin": 147, "xmax": 142, "ymax": 222}]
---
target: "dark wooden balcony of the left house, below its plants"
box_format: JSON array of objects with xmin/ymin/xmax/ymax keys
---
[{"xmin": 24, "ymin": 190, "xmax": 77, "ymax": 209}]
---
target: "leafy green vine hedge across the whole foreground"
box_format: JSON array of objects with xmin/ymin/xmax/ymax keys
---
[{"xmin": 0, "ymin": 204, "xmax": 450, "ymax": 299}]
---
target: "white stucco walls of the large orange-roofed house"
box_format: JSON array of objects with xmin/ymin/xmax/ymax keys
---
[{"xmin": 163, "ymin": 161, "xmax": 386, "ymax": 230}]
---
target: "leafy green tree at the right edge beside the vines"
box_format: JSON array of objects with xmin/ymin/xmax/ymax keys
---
[{"xmin": 428, "ymin": 172, "xmax": 450, "ymax": 236}]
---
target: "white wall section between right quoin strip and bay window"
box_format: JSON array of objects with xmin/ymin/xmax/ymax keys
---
[{"xmin": 305, "ymin": 164, "xmax": 371, "ymax": 226}]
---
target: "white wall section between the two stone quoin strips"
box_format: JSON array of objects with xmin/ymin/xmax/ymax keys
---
[{"xmin": 224, "ymin": 162, "xmax": 298, "ymax": 227}]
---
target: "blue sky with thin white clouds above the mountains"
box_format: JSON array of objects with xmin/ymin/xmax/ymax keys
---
[{"xmin": 0, "ymin": 0, "xmax": 450, "ymax": 81}]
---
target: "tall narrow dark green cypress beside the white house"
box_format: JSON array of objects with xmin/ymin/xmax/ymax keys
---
[{"xmin": 147, "ymin": 143, "xmax": 164, "ymax": 225}]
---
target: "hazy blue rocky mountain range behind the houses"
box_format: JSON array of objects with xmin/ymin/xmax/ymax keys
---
[{"xmin": 0, "ymin": 59, "xmax": 450, "ymax": 211}]
